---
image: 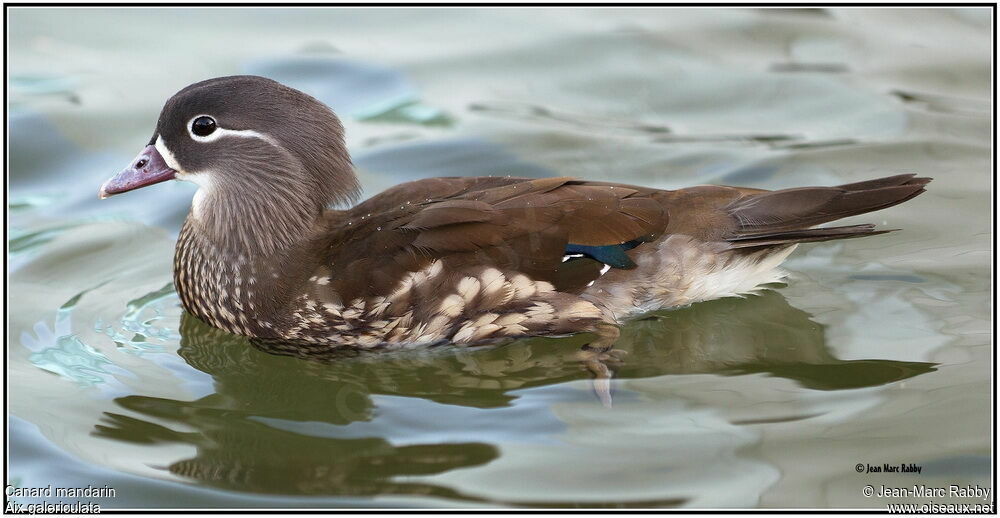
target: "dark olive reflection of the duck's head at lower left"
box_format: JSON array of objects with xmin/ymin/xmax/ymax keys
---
[{"xmin": 96, "ymin": 406, "xmax": 497, "ymax": 500}]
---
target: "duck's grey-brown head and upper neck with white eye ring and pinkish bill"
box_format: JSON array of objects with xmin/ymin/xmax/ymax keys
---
[{"xmin": 100, "ymin": 76, "xmax": 358, "ymax": 253}]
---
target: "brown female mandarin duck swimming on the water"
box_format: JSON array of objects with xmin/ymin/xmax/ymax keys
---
[{"xmin": 100, "ymin": 76, "xmax": 930, "ymax": 370}]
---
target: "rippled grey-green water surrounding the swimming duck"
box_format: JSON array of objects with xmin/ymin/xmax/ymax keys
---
[{"xmin": 7, "ymin": 8, "xmax": 993, "ymax": 508}]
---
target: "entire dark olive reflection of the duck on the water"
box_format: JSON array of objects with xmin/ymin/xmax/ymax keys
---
[{"xmin": 95, "ymin": 292, "xmax": 933, "ymax": 506}]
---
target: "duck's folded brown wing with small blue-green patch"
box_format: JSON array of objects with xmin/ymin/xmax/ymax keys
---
[{"xmin": 326, "ymin": 177, "xmax": 667, "ymax": 297}]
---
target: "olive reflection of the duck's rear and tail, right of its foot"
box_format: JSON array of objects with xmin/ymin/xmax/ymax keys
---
[{"xmin": 620, "ymin": 291, "xmax": 934, "ymax": 390}]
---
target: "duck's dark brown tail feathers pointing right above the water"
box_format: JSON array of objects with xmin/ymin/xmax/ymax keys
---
[{"xmin": 726, "ymin": 174, "xmax": 931, "ymax": 248}]
